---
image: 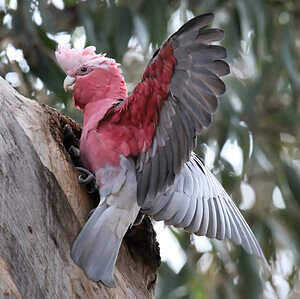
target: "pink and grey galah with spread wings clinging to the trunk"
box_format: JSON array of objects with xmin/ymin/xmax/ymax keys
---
[{"xmin": 56, "ymin": 14, "xmax": 264, "ymax": 287}]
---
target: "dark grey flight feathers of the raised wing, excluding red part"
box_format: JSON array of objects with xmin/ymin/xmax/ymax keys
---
[{"xmin": 137, "ymin": 14, "xmax": 229, "ymax": 205}]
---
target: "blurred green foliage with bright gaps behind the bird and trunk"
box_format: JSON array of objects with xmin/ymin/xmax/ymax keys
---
[{"xmin": 0, "ymin": 0, "xmax": 300, "ymax": 299}]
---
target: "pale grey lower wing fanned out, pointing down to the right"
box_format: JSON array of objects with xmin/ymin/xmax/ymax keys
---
[{"xmin": 142, "ymin": 154, "xmax": 265, "ymax": 260}]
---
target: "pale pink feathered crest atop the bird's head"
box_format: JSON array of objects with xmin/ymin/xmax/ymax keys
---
[{"xmin": 55, "ymin": 44, "xmax": 117, "ymax": 76}]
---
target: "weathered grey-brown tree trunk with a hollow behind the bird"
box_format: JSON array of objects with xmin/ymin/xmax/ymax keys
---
[{"xmin": 0, "ymin": 78, "xmax": 160, "ymax": 299}]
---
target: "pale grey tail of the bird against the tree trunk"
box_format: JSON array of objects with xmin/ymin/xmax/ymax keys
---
[{"xmin": 71, "ymin": 203, "xmax": 124, "ymax": 287}]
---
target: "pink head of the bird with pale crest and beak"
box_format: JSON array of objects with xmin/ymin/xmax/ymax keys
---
[{"xmin": 55, "ymin": 45, "xmax": 127, "ymax": 110}]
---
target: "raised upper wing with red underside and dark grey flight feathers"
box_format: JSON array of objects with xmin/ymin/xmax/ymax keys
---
[{"xmin": 106, "ymin": 14, "xmax": 229, "ymax": 205}]
